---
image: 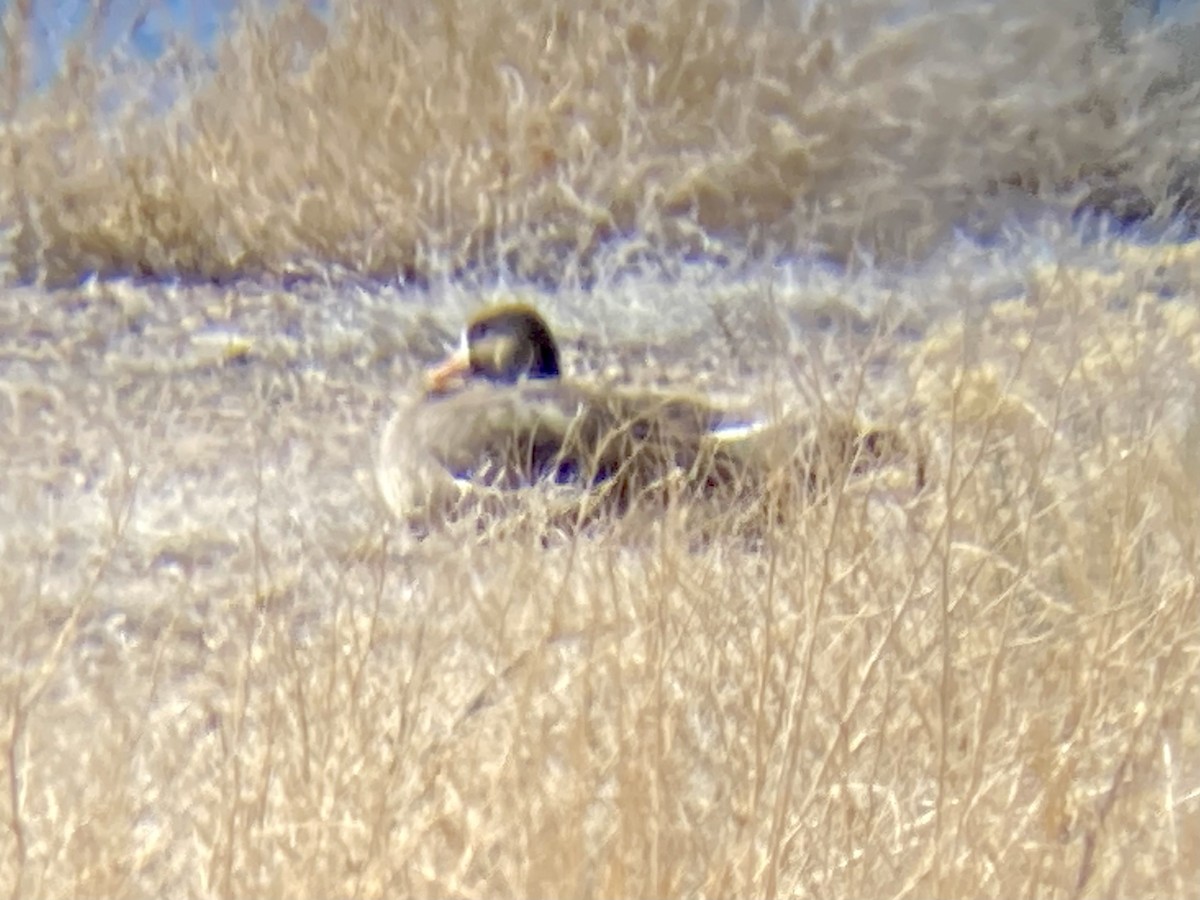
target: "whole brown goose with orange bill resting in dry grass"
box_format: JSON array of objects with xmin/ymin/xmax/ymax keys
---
[{"xmin": 377, "ymin": 304, "xmax": 916, "ymax": 528}]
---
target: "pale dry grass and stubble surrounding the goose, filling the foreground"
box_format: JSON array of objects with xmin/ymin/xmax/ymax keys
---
[{"xmin": 0, "ymin": 246, "xmax": 1200, "ymax": 898}]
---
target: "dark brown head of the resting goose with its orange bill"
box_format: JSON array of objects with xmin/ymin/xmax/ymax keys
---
[{"xmin": 425, "ymin": 304, "xmax": 559, "ymax": 395}]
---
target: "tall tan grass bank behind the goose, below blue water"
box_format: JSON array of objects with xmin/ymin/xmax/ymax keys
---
[{"xmin": 0, "ymin": 0, "xmax": 1200, "ymax": 283}]
